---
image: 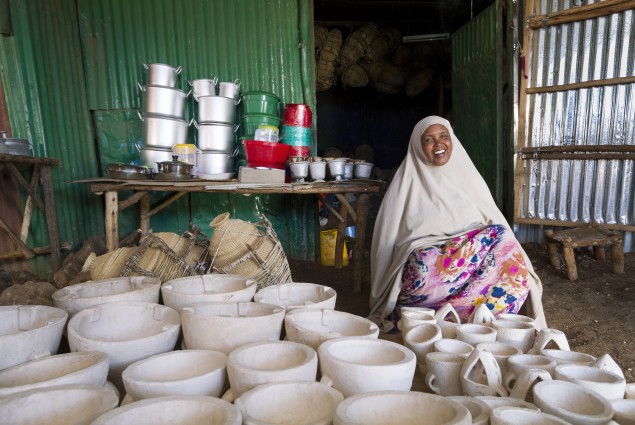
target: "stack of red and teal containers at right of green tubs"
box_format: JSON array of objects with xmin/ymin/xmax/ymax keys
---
[{"xmin": 280, "ymin": 103, "xmax": 313, "ymax": 158}]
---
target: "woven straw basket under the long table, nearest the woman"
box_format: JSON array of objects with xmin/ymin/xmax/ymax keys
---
[{"xmin": 208, "ymin": 213, "xmax": 292, "ymax": 289}]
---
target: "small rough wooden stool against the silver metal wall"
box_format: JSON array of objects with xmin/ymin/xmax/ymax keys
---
[{"xmin": 545, "ymin": 226, "xmax": 624, "ymax": 280}]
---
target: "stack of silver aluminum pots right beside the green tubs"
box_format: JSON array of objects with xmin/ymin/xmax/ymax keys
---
[{"xmin": 191, "ymin": 79, "xmax": 240, "ymax": 176}]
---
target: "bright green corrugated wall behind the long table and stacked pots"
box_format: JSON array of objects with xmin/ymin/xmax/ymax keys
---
[{"xmin": 78, "ymin": 0, "xmax": 317, "ymax": 259}]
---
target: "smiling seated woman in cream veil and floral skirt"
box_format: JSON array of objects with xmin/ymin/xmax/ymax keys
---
[{"xmin": 370, "ymin": 116, "xmax": 546, "ymax": 330}]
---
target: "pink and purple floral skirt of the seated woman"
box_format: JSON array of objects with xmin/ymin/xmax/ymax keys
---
[{"xmin": 395, "ymin": 225, "xmax": 529, "ymax": 322}]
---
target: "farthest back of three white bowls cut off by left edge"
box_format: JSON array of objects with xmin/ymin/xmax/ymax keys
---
[{"xmin": 0, "ymin": 305, "xmax": 68, "ymax": 370}]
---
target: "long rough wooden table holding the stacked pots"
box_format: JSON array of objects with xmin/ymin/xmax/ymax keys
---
[{"xmin": 83, "ymin": 178, "xmax": 384, "ymax": 292}]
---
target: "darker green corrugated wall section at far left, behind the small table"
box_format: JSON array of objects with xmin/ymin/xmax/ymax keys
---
[{"xmin": 0, "ymin": 0, "xmax": 103, "ymax": 275}]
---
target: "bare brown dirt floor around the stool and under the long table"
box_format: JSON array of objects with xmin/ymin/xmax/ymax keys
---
[{"xmin": 290, "ymin": 245, "xmax": 635, "ymax": 382}]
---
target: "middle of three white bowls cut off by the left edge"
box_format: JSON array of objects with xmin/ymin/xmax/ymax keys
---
[{"xmin": 0, "ymin": 351, "xmax": 110, "ymax": 397}]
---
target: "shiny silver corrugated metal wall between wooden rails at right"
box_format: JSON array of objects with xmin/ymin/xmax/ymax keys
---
[{"xmin": 519, "ymin": 0, "xmax": 635, "ymax": 248}]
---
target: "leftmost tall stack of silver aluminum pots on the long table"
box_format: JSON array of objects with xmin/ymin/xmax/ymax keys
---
[{"xmin": 138, "ymin": 63, "xmax": 191, "ymax": 172}]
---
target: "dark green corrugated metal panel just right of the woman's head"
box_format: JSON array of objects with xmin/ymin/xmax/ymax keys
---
[{"xmin": 452, "ymin": 1, "xmax": 506, "ymax": 207}]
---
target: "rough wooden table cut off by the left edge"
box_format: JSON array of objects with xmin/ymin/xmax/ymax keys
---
[{"xmin": 0, "ymin": 154, "xmax": 61, "ymax": 272}]
